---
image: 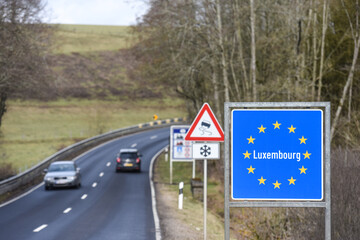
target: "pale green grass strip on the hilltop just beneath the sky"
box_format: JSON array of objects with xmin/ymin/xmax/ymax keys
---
[{"xmin": 53, "ymin": 24, "xmax": 136, "ymax": 54}]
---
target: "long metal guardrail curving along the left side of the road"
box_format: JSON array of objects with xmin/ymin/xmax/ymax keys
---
[{"xmin": 0, "ymin": 118, "xmax": 186, "ymax": 195}]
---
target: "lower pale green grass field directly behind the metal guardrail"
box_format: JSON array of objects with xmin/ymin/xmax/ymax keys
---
[{"xmin": 0, "ymin": 99, "xmax": 185, "ymax": 171}]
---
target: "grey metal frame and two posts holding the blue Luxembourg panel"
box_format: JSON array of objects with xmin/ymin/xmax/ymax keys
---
[{"xmin": 224, "ymin": 102, "xmax": 331, "ymax": 240}]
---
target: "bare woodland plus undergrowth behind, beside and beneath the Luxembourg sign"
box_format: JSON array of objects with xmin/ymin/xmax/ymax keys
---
[{"xmin": 131, "ymin": 0, "xmax": 360, "ymax": 239}]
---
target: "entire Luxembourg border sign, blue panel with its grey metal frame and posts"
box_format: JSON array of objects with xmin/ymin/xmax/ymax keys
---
[{"xmin": 224, "ymin": 102, "xmax": 331, "ymax": 240}]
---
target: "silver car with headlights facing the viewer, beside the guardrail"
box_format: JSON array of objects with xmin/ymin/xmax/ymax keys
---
[{"xmin": 44, "ymin": 161, "xmax": 81, "ymax": 190}]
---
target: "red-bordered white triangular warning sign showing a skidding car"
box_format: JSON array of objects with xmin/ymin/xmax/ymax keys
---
[{"xmin": 185, "ymin": 103, "xmax": 224, "ymax": 142}]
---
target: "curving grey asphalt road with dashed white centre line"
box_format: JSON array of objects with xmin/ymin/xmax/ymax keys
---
[{"xmin": 0, "ymin": 128, "xmax": 169, "ymax": 240}]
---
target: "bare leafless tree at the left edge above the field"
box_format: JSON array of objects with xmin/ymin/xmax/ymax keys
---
[{"xmin": 0, "ymin": 0, "xmax": 47, "ymax": 126}]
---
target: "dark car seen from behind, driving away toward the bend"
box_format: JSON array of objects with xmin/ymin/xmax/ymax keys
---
[{"xmin": 116, "ymin": 148, "xmax": 142, "ymax": 172}]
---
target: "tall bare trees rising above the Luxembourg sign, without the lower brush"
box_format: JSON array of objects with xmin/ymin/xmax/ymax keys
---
[{"xmin": 132, "ymin": 0, "xmax": 360, "ymax": 148}]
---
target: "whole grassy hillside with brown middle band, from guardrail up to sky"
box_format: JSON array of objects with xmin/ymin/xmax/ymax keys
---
[{"xmin": 0, "ymin": 25, "xmax": 186, "ymax": 176}]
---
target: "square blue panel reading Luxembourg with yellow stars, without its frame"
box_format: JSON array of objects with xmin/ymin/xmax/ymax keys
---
[{"xmin": 231, "ymin": 109, "xmax": 323, "ymax": 201}]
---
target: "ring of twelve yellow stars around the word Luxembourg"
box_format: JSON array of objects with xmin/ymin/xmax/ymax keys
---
[{"xmin": 243, "ymin": 121, "xmax": 311, "ymax": 189}]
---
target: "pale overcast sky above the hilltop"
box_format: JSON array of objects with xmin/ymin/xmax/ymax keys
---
[{"xmin": 44, "ymin": 0, "xmax": 147, "ymax": 25}]
